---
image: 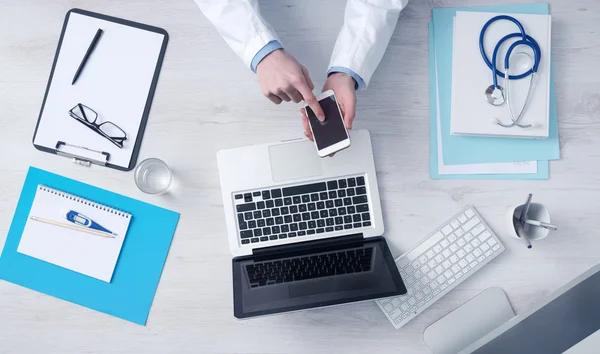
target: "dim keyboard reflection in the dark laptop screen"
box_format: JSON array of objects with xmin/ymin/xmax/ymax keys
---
[{"xmin": 246, "ymin": 248, "xmax": 373, "ymax": 288}]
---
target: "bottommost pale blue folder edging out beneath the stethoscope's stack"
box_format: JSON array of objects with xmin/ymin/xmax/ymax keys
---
[{"xmin": 429, "ymin": 22, "xmax": 548, "ymax": 180}]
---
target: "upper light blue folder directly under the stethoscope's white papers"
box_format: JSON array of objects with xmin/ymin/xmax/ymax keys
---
[{"xmin": 432, "ymin": 4, "xmax": 560, "ymax": 165}]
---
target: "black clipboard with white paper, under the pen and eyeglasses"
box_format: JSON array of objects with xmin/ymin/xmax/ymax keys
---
[{"xmin": 32, "ymin": 9, "xmax": 169, "ymax": 171}]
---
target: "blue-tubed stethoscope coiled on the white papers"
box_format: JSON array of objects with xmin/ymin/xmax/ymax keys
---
[{"xmin": 479, "ymin": 15, "xmax": 541, "ymax": 128}]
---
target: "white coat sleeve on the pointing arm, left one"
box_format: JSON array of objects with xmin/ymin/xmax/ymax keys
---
[{"xmin": 194, "ymin": 0, "xmax": 281, "ymax": 67}]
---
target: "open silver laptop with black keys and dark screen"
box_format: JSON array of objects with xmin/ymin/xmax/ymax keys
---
[{"xmin": 217, "ymin": 130, "xmax": 406, "ymax": 318}]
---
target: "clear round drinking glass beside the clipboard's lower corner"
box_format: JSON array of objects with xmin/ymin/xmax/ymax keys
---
[{"xmin": 134, "ymin": 158, "xmax": 173, "ymax": 194}]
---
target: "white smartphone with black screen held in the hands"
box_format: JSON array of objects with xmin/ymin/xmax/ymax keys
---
[{"xmin": 304, "ymin": 90, "xmax": 350, "ymax": 157}]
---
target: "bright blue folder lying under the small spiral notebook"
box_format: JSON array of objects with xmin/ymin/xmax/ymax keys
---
[{"xmin": 0, "ymin": 167, "xmax": 179, "ymax": 325}]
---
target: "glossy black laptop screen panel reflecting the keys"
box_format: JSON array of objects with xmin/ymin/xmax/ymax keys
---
[{"xmin": 233, "ymin": 237, "xmax": 406, "ymax": 318}]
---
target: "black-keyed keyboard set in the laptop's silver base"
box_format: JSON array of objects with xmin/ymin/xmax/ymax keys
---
[{"xmin": 234, "ymin": 176, "xmax": 372, "ymax": 245}]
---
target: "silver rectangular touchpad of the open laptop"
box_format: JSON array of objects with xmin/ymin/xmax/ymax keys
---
[{"xmin": 269, "ymin": 141, "xmax": 323, "ymax": 182}]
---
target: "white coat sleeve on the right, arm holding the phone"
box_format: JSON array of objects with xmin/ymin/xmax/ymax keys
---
[{"xmin": 329, "ymin": 0, "xmax": 408, "ymax": 87}]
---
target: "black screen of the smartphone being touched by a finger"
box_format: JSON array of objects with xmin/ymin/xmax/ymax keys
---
[{"xmin": 306, "ymin": 95, "xmax": 348, "ymax": 150}]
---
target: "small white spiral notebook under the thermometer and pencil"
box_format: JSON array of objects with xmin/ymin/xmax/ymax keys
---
[{"xmin": 17, "ymin": 184, "xmax": 131, "ymax": 283}]
